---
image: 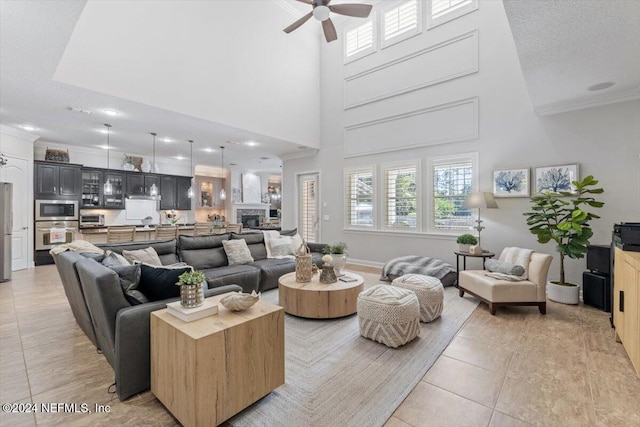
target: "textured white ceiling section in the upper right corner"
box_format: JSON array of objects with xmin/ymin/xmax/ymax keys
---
[{"xmin": 504, "ymin": 0, "xmax": 640, "ymax": 112}]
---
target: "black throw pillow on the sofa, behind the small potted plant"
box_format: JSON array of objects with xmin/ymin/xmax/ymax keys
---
[{"xmin": 133, "ymin": 264, "xmax": 193, "ymax": 301}]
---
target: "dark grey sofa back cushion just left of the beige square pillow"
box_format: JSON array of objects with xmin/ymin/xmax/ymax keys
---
[{"xmin": 178, "ymin": 233, "xmax": 229, "ymax": 270}]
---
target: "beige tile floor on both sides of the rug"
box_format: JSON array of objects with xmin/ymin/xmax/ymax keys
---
[{"xmin": 0, "ymin": 266, "xmax": 640, "ymax": 427}]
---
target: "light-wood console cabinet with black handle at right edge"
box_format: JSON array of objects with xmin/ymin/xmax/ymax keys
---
[{"xmin": 613, "ymin": 248, "xmax": 640, "ymax": 377}]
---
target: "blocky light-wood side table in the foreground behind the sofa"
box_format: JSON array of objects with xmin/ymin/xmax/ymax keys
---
[{"xmin": 151, "ymin": 294, "xmax": 284, "ymax": 426}]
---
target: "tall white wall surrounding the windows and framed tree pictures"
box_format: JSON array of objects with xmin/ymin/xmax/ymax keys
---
[{"xmin": 283, "ymin": 1, "xmax": 640, "ymax": 283}]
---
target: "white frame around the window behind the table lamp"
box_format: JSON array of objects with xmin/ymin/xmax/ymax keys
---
[{"xmin": 426, "ymin": 152, "xmax": 479, "ymax": 235}]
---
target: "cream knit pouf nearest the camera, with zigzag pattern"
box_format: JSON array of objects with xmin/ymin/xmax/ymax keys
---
[{"xmin": 358, "ymin": 285, "xmax": 420, "ymax": 348}]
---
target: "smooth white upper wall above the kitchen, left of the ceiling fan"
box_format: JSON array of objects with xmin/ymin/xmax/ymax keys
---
[{"xmin": 54, "ymin": 0, "xmax": 320, "ymax": 147}]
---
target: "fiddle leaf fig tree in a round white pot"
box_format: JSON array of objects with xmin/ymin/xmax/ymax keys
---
[{"xmin": 523, "ymin": 175, "xmax": 604, "ymax": 304}]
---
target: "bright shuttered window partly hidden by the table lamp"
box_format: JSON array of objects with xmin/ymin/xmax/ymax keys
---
[{"xmin": 430, "ymin": 154, "xmax": 477, "ymax": 231}]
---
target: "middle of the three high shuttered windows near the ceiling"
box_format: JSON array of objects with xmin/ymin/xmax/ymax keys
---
[{"xmin": 380, "ymin": 0, "xmax": 422, "ymax": 47}]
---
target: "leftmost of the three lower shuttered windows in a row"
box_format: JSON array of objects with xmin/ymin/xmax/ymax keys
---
[{"xmin": 345, "ymin": 167, "xmax": 375, "ymax": 228}]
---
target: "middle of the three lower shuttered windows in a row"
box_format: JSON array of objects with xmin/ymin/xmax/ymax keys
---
[{"xmin": 384, "ymin": 164, "xmax": 419, "ymax": 230}]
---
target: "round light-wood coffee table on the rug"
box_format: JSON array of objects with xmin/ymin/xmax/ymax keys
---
[{"xmin": 278, "ymin": 272, "xmax": 364, "ymax": 319}]
